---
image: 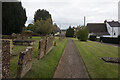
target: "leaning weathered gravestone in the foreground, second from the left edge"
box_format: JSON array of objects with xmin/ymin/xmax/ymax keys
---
[{"xmin": 17, "ymin": 47, "xmax": 33, "ymax": 78}]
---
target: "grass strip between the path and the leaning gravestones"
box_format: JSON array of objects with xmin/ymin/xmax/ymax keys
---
[{"xmin": 24, "ymin": 39, "xmax": 67, "ymax": 78}]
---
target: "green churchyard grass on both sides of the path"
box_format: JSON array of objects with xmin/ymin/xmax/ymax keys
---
[{"xmin": 10, "ymin": 37, "xmax": 118, "ymax": 78}]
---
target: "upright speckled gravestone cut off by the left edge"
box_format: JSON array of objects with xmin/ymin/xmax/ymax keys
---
[{"xmin": 0, "ymin": 40, "xmax": 10, "ymax": 78}]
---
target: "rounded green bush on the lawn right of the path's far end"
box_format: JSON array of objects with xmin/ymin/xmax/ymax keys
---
[{"xmin": 76, "ymin": 26, "xmax": 88, "ymax": 41}]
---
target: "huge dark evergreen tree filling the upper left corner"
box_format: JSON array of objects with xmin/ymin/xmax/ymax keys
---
[{"xmin": 2, "ymin": 2, "xmax": 27, "ymax": 35}]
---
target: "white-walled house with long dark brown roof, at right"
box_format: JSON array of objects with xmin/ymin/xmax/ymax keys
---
[{"xmin": 87, "ymin": 21, "xmax": 120, "ymax": 37}]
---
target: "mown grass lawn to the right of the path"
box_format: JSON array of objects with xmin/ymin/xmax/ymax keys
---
[{"xmin": 73, "ymin": 39, "xmax": 118, "ymax": 78}]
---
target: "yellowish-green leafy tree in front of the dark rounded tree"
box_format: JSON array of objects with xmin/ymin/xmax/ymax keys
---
[{"xmin": 34, "ymin": 18, "xmax": 53, "ymax": 36}]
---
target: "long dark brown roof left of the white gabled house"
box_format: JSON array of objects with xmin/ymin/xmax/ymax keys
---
[{"xmin": 87, "ymin": 23, "xmax": 109, "ymax": 35}]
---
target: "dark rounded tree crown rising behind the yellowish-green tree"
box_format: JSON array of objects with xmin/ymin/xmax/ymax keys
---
[{"xmin": 34, "ymin": 9, "xmax": 52, "ymax": 22}]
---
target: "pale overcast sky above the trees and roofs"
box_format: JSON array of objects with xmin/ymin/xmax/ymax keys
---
[{"xmin": 21, "ymin": 0, "xmax": 119, "ymax": 29}]
